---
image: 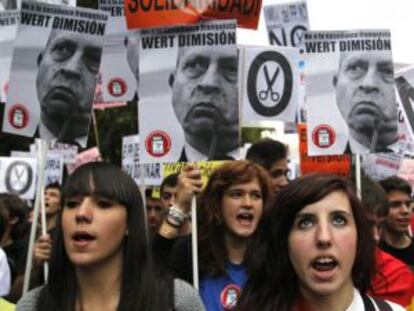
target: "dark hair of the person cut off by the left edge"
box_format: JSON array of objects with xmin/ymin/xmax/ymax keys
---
[{"xmin": 0, "ymin": 193, "xmax": 30, "ymax": 241}]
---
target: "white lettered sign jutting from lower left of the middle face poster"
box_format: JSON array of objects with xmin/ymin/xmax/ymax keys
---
[{"xmin": 122, "ymin": 135, "xmax": 162, "ymax": 186}]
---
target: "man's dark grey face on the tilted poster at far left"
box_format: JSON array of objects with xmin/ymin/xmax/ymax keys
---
[{"xmin": 36, "ymin": 31, "xmax": 102, "ymax": 140}]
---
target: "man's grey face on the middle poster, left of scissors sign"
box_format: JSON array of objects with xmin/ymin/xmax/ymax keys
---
[{"xmin": 170, "ymin": 47, "xmax": 239, "ymax": 144}]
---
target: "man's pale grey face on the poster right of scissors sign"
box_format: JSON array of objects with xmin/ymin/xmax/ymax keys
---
[{"xmin": 334, "ymin": 51, "xmax": 397, "ymax": 144}]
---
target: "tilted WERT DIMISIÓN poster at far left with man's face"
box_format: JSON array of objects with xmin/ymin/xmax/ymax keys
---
[{"xmin": 3, "ymin": 1, "xmax": 108, "ymax": 146}]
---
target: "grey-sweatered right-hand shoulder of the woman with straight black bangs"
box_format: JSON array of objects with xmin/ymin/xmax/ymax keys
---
[{"xmin": 174, "ymin": 279, "xmax": 205, "ymax": 311}]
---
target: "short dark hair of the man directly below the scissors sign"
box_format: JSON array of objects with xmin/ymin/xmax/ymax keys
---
[{"xmin": 246, "ymin": 139, "xmax": 288, "ymax": 171}]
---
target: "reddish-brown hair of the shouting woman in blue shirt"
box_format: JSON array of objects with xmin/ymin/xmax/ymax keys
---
[{"xmin": 197, "ymin": 161, "xmax": 269, "ymax": 276}]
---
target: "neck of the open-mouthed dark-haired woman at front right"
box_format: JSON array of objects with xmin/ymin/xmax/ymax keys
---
[{"xmin": 295, "ymin": 284, "xmax": 354, "ymax": 311}]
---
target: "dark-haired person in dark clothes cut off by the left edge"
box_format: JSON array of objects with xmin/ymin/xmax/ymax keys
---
[{"xmin": 0, "ymin": 193, "xmax": 30, "ymax": 302}]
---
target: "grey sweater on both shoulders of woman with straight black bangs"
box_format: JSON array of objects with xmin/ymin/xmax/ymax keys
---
[{"xmin": 16, "ymin": 279, "xmax": 205, "ymax": 311}]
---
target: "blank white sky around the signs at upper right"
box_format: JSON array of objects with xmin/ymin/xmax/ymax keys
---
[{"xmin": 237, "ymin": 0, "xmax": 414, "ymax": 64}]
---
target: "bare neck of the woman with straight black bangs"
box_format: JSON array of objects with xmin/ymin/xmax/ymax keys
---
[{"xmin": 76, "ymin": 256, "xmax": 122, "ymax": 311}]
